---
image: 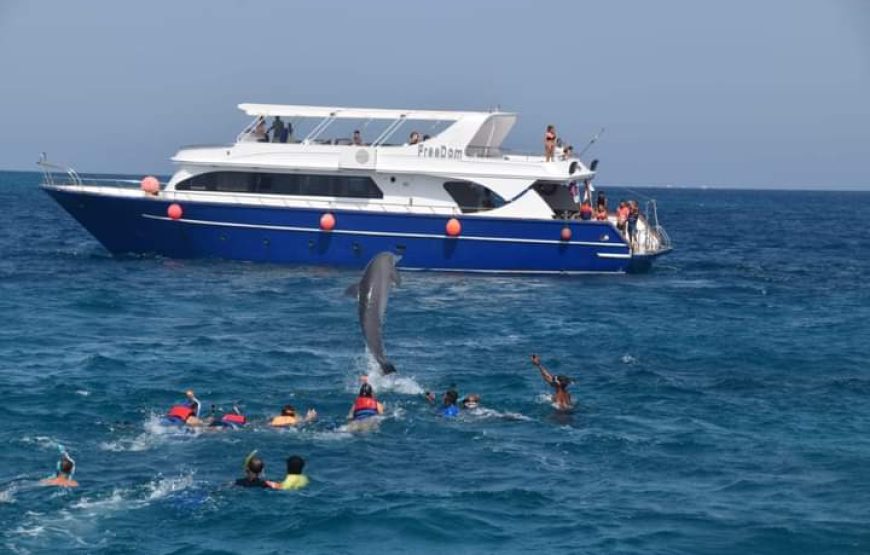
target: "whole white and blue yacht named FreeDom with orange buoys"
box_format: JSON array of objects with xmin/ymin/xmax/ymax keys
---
[{"xmin": 40, "ymin": 104, "xmax": 671, "ymax": 274}]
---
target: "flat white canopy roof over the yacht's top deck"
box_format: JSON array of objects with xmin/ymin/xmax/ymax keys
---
[{"xmin": 239, "ymin": 103, "xmax": 513, "ymax": 121}]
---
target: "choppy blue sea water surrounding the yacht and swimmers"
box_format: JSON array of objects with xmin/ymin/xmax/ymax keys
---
[{"xmin": 0, "ymin": 173, "xmax": 870, "ymax": 555}]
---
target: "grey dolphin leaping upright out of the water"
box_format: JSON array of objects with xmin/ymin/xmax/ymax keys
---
[{"xmin": 346, "ymin": 252, "xmax": 401, "ymax": 374}]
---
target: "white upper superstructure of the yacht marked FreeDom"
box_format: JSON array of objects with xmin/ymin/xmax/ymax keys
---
[{"xmin": 166, "ymin": 104, "xmax": 595, "ymax": 219}]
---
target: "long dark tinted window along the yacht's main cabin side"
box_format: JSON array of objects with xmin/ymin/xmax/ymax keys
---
[{"xmin": 175, "ymin": 172, "xmax": 384, "ymax": 202}]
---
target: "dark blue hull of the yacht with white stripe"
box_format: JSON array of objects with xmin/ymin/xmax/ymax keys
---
[{"xmin": 46, "ymin": 188, "xmax": 668, "ymax": 273}]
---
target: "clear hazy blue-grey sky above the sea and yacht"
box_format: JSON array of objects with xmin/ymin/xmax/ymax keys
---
[{"xmin": 0, "ymin": 0, "xmax": 870, "ymax": 190}]
